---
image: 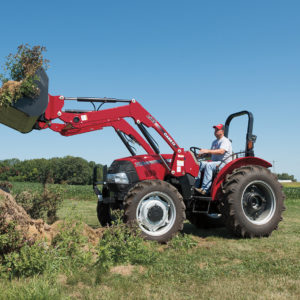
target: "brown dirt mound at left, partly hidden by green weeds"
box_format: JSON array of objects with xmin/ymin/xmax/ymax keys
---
[{"xmin": 0, "ymin": 189, "xmax": 103, "ymax": 245}]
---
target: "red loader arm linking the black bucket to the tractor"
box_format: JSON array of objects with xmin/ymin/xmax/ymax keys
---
[{"xmin": 38, "ymin": 95, "xmax": 185, "ymax": 176}]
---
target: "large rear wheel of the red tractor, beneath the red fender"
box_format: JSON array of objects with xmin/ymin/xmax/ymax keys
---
[{"xmin": 220, "ymin": 165, "xmax": 285, "ymax": 238}]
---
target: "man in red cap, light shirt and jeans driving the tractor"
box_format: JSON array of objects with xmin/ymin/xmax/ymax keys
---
[{"xmin": 195, "ymin": 124, "xmax": 232, "ymax": 196}]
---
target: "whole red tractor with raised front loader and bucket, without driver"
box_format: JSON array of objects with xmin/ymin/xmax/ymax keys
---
[{"xmin": 0, "ymin": 70, "xmax": 284, "ymax": 242}]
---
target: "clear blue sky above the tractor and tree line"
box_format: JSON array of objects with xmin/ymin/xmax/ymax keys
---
[{"xmin": 0, "ymin": 0, "xmax": 300, "ymax": 180}]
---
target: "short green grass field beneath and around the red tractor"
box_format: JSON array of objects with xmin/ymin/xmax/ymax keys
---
[{"xmin": 0, "ymin": 182, "xmax": 300, "ymax": 300}]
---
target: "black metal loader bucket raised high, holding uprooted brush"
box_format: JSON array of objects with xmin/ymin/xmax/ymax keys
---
[{"xmin": 0, "ymin": 69, "xmax": 49, "ymax": 133}]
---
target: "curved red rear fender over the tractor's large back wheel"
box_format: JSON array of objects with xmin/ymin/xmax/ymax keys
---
[{"xmin": 211, "ymin": 156, "xmax": 272, "ymax": 201}]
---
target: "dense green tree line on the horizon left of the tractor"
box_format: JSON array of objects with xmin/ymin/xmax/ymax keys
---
[{"xmin": 0, "ymin": 156, "xmax": 102, "ymax": 185}]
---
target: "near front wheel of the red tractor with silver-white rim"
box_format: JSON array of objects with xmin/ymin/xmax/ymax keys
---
[{"xmin": 125, "ymin": 180, "xmax": 185, "ymax": 243}]
